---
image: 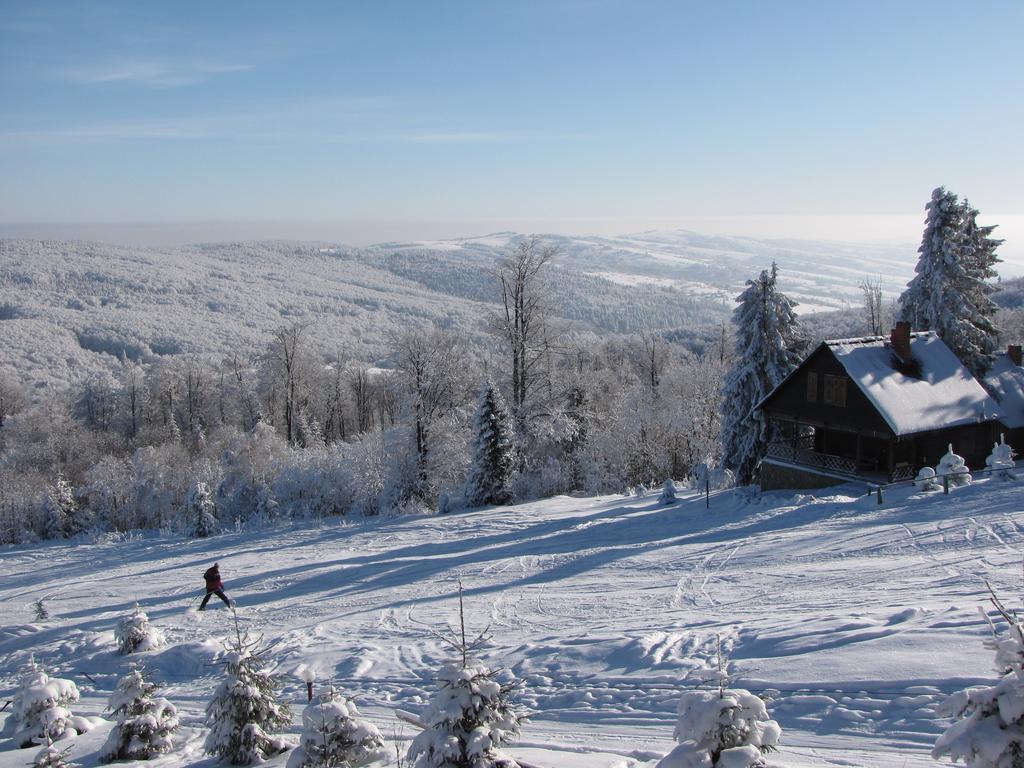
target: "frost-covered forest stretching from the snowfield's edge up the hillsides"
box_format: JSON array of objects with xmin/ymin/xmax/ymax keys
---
[{"xmin": 0, "ymin": 215, "xmax": 1022, "ymax": 542}]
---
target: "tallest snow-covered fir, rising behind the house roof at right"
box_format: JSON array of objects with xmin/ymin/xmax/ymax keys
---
[{"xmin": 899, "ymin": 186, "xmax": 1002, "ymax": 376}]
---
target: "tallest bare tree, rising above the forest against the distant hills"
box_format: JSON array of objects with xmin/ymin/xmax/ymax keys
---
[{"xmin": 495, "ymin": 237, "xmax": 558, "ymax": 423}]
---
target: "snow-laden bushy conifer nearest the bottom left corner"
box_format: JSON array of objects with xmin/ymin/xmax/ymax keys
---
[{"xmin": 4, "ymin": 660, "xmax": 92, "ymax": 748}]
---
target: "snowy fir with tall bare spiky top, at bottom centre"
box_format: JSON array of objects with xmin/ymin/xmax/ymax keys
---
[{"xmin": 409, "ymin": 584, "xmax": 525, "ymax": 768}]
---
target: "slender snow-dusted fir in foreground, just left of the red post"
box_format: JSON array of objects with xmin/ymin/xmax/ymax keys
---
[{"xmin": 205, "ymin": 616, "xmax": 292, "ymax": 765}]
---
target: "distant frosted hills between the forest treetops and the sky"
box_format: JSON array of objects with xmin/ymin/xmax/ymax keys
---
[{"xmin": 0, "ymin": 231, "xmax": 914, "ymax": 386}]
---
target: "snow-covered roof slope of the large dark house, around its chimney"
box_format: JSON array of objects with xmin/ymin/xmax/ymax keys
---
[{"xmin": 825, "ymin": 332, "xmax": 1002, "ymax": 435}]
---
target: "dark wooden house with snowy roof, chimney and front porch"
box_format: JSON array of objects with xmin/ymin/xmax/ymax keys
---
[{"xmin": 758, "ymin": 323, "xmax": 1004, "ymax": 488}]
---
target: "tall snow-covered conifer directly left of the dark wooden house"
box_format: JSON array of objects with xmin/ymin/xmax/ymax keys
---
[{"xmin": 722, "ymin": 263, "xmax": 807, "ymax": 485}]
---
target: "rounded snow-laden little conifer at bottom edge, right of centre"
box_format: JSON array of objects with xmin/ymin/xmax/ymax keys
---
[{"xmin": 657, "ymin": 688, "xmax": 782, "ymax": 768}]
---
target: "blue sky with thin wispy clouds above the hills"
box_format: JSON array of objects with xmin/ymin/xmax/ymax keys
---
[{"xmin": 0, "ymin": 0, "xmax": 1024, "ymax": 263}]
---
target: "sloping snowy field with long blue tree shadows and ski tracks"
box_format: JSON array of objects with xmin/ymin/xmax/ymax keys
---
[{"xmin": 0, "ymin": 480, "xmax": 1024, "ymax": 768}]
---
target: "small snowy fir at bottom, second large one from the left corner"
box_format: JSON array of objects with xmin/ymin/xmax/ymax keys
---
[{"xmin": 100, "ymin": 667, "xmax": 178, "ymax": 763}]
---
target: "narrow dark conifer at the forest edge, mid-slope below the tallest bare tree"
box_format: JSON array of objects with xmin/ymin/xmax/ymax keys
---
[{"xmin": 466, "ymin": 382, "xmax": 515, "ymax": 507}]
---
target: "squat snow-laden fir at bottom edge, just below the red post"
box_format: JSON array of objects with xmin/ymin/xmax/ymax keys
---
[{"xmin": 289, "ymin": 687, "xmax": 385, "ymax": 768}]
